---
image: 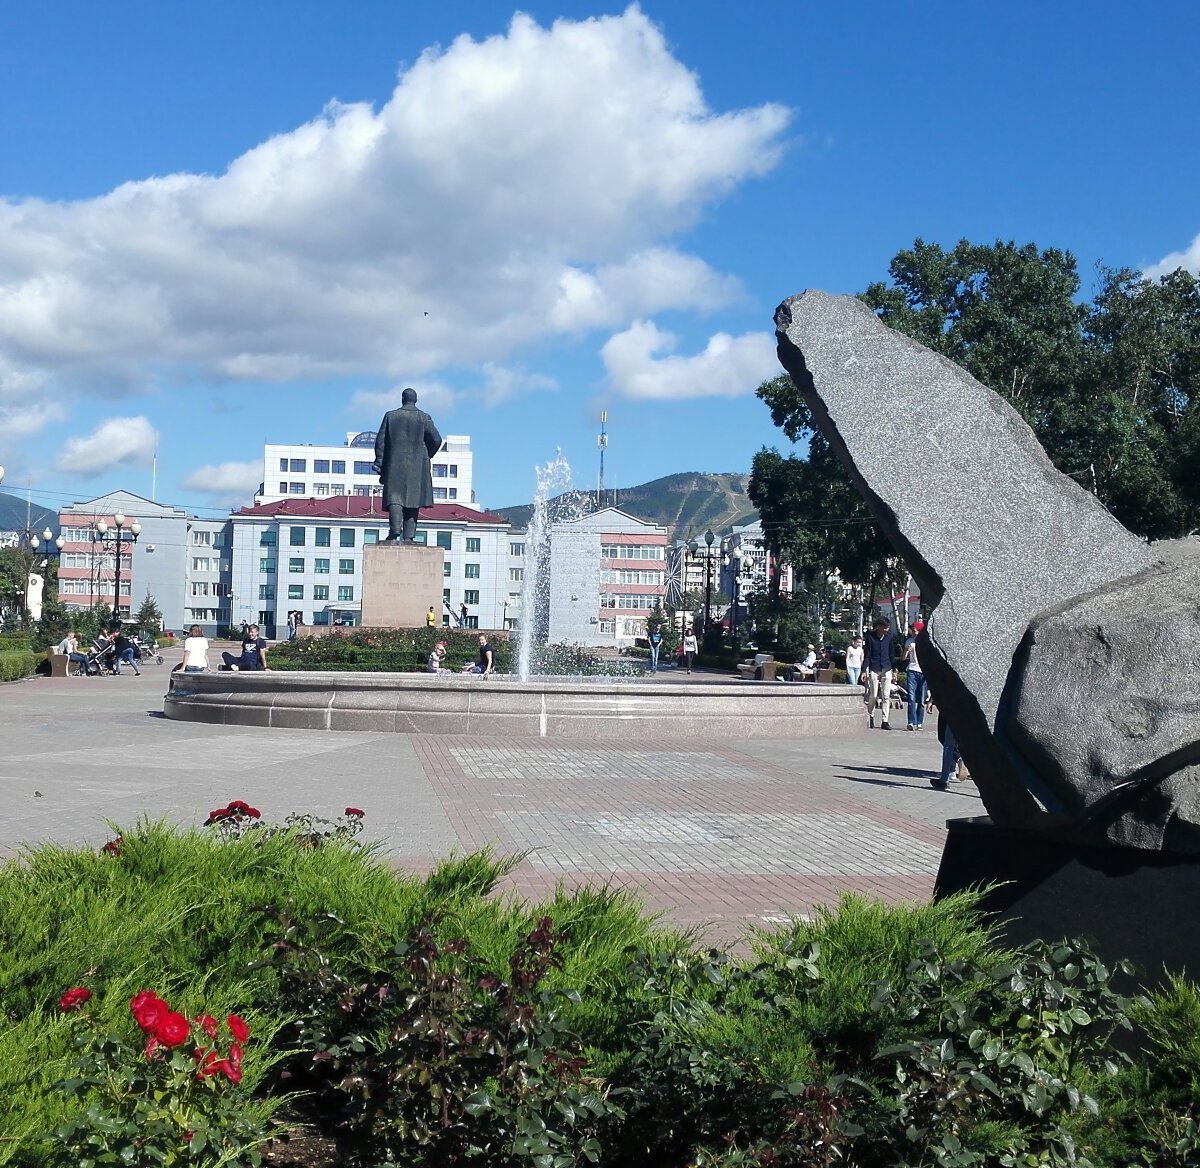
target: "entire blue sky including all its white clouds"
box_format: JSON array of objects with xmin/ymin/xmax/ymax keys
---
[{"xmin": 0, "ymin": 0, "xmax": 1200, "ymax": 514}]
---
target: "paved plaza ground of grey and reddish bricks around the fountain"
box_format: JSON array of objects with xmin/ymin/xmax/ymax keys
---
[{"xmin": 0, "ymin": 651, "xmax": 983, "ymax": 941}]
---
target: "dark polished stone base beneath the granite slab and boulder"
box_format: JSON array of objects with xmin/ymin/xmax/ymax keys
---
[{"xmin": 934, "ymin": 816, "xmax": 1200, "ymax": 987}]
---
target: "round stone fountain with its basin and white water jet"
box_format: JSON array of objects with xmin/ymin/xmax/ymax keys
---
[{"xmin": 163, "ymin": 451, "xmax": 864, "ymax": 742}]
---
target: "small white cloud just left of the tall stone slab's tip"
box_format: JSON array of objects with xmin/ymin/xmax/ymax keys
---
[{"xmin": 600, "ymin": 321, "xmax": 779, "ymax": 401}]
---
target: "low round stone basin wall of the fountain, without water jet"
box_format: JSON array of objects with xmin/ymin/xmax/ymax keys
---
[{"xmin": 163, "ymin": 671, "xmax": 864, "ymax": 741}]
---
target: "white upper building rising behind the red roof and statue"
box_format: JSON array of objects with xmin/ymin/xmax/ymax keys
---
[{"xmin": 254, "ymin": 430, "xmax": 475, "ymax": 507}]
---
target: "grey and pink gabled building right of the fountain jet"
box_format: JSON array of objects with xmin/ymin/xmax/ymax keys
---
[{"xmin": 546, "ymin": 507, "xmax": 667, "ymax": 647}]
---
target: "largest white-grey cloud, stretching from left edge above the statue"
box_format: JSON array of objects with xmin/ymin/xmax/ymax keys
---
[{"xmin": 0, "ymin": 7, "xmax": 788, "ymax": 422}]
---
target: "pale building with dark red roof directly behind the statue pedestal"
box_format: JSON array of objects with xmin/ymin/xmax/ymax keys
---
[{"xmin": 230, "ymin": 495, "xmax": 514, "ymax": 637}]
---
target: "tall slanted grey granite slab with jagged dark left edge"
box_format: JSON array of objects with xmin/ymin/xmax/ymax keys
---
[{"xmin": 775, "ymin": 292, "xmax": 1156, "ymax": 826}]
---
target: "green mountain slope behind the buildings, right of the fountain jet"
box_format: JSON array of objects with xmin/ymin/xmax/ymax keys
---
[{"xmin": 494, "ymin": 471, "xmax": 758, "ymax": 539}]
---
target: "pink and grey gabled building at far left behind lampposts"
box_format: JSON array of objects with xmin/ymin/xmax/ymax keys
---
[{"xmin": 59, "ymin": 491, "xmax": 188, "ymax": 629}]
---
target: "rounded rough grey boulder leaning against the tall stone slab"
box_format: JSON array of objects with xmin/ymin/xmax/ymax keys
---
[{"xmin": 997, "ymin": 539, "xmax": 1200, "ymax": 851}]
